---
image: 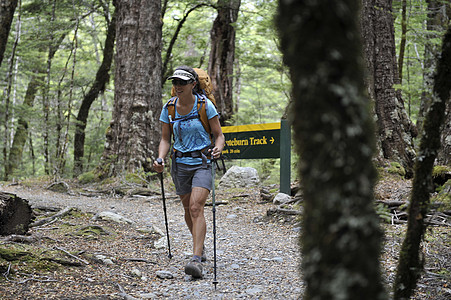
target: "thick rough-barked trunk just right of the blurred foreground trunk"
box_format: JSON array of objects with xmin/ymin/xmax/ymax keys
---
[{"xmin": 361, "ymin": 0, "xmax": 416, "ymax": 176}]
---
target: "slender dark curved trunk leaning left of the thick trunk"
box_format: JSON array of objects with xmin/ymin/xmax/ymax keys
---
[{"xmin": 74, "ymin": 13, "xmax": 116, "ymax": 176}]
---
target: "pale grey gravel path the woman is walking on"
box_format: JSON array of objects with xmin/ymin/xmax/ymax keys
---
[{"xmin": 0, "ymin": 185, "xmax": 303, "ymax": 299}]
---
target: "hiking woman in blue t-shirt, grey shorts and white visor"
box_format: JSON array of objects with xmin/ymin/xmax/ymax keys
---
[{"xmin": 153, "ymin": 66, "xmax": 224, "ymax": 278}]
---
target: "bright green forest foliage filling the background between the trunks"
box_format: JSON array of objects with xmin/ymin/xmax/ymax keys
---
[{"xmin": 0, "ymin": 0, "xmax": 448, "ymax": 182}]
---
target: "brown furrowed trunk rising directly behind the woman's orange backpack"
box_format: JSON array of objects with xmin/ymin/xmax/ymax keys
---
[{"xmin": 208, "ymin": 0, "xmax": 241, "ymax": 125}]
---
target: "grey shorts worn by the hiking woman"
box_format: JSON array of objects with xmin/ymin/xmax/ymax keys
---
[{"xmin": 171, "ymin": 163, "xmax": 212, "ymax": 195}]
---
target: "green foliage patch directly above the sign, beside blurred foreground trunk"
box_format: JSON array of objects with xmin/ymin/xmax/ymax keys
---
[{"xmin": 233, "ymin": 1, "xmax": 291, "ymax": 125}]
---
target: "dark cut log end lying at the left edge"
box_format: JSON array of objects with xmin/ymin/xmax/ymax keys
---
[{"xmin": 0, "ymin": 192, "xmax": 33, "ymax": 235}]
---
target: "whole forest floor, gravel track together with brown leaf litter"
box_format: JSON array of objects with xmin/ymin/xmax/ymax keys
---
[{"xmin": 0, "ymin": 176, "xmax": 451, "ymax": 299}]
